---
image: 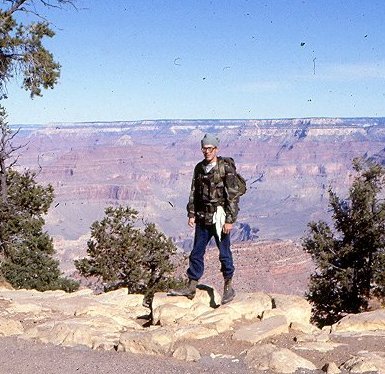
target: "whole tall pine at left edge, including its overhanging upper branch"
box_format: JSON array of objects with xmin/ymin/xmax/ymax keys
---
[{"xmin": 0, "ymin": 0, "xmax": 78, "ymax": 291}]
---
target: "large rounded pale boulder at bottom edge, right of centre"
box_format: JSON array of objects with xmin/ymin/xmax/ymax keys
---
[{"xmin": 246, "ymin": 344, "xmax": 317, "ymax": 373}]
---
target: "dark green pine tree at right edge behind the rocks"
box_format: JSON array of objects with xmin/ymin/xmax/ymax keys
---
[{"xmin": 303, "ymin": 159, "xmax": 385, "ymax": 326}]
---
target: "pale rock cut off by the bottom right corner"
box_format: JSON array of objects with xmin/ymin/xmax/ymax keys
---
[{"xmin": 343, "ymin": 352, "xmax": 385, "ymax": 374}]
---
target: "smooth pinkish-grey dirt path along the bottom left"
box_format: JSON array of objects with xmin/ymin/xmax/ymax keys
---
[{"xmin": 0, "ymin": 338, "xmax": 249, "ymax": 374}]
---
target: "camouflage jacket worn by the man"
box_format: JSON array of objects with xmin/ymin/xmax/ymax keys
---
[{"xmin": 187, "ymin": 157, "xmax": 239, "ymax": 225}]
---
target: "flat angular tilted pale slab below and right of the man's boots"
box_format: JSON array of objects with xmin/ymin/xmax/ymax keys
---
[{"xmin": 232, "ymin": 316, "xmax": 289, "ymax": 344}]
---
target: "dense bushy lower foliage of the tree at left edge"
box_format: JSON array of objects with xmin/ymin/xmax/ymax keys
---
[{"xmin": 0, "ymin": 169, "xmax": 79, "ymax": 292}]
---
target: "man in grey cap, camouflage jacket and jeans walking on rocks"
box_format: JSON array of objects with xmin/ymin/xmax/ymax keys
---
[{"xmin": 171, "ymin": 134, "xmax": 239, "ymax": 304}]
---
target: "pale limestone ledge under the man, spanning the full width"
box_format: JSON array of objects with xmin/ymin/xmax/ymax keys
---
[{"xmin": 0, "ymin": 285, "xmax": 385, "ymax": 373}]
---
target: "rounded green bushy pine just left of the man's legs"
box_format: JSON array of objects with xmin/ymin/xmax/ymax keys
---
[{"xmin": 75, "ymin": 206, "xmax": 182, "ymax": 299}]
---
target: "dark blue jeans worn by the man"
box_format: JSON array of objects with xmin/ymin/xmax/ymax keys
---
[{"xmin": 187, "ymin": 224, "xmax": 234, "ymax": 280}]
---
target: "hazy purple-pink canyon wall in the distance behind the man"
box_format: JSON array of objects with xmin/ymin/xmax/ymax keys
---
[{"xmin": 11, "ymin": 118, "xmax": 385, "ymax": 268}]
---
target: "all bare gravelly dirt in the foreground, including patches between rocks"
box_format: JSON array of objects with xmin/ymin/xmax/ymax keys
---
[{"xmin": 0, "ymin": 322, "xmax": 385, "ymax": 374}]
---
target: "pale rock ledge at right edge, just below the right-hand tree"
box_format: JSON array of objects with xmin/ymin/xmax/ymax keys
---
[{"xmin": 332, "ymin": 309, "xmax": 385, "ymax": 333}]
